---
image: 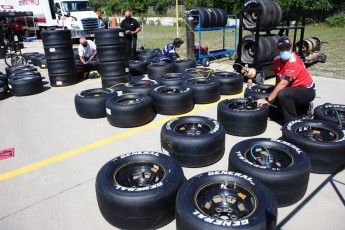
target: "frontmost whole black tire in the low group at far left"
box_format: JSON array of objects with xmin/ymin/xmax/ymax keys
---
[{"xmin": 8, "ymin": 75, "xmax": 43, "ymax": 96}]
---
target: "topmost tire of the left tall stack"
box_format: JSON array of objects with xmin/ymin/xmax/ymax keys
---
[{"xmin": 41, "ymin": 30, "xmax": 72, "ymax": 46}]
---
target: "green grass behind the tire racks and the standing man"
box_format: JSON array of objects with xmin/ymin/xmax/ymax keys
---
[{"xmin": 134, "ymin": 24, "xmax": 345, "ymax": 79}]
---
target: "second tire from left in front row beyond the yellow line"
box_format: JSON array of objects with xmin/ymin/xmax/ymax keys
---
[{"xmin": 105, "ymin": 94, "xmax": 155, "ymax": 128}]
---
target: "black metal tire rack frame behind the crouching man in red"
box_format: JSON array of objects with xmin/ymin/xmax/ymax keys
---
[{"xmin": 233, "ymin": 7, "xmax": 305, "ymax": 83}]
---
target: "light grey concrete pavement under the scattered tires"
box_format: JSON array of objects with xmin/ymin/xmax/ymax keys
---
[{"xmin": 0, "ymin": 41, "xmax": 345, "ymax": 230}]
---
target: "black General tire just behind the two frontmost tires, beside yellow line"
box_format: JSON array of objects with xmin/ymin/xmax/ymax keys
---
[{"xmin": 161, "ymin": 116, "xmax": 225, "ymax": 167}]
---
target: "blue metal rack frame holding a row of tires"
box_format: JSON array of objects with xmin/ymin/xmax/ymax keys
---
[{"xmin": 192, "ymin": 14, "xmax": 237, "ymax": 66}]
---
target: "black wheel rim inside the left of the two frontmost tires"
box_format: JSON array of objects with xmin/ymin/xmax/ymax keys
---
[{"xmin": 114, "ymin": 162, "xmax": 165, "ymax": 188}]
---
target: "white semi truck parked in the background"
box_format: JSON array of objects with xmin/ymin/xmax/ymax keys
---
[{"xmin": 0, "ymin": 0, "xmax": 102, "ymax": 37}]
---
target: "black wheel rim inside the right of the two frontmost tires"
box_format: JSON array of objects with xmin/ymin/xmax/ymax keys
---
[{"xmin": 195, "ymin": 181, "xmax": 257, "ymax": 220}]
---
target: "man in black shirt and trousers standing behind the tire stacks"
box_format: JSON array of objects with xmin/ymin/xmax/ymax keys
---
[{"xmin": 120, "ymin": 10, "xmax": 141, "ymax": 60}]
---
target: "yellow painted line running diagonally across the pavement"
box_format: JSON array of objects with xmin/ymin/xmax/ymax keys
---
[{"xmin": 0, "ymin": 79, "xmax": 274, "ymax": 181}]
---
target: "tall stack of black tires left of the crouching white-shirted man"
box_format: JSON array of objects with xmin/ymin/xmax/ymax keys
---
[{"xmin": 41, "ymin": 30, "xmax": 78, "ymax": 86}]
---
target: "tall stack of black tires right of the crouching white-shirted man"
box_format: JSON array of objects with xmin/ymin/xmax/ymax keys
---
[{"xmin": 95, "ymin": 28, "xmax": 131, "ymax": 90}]
